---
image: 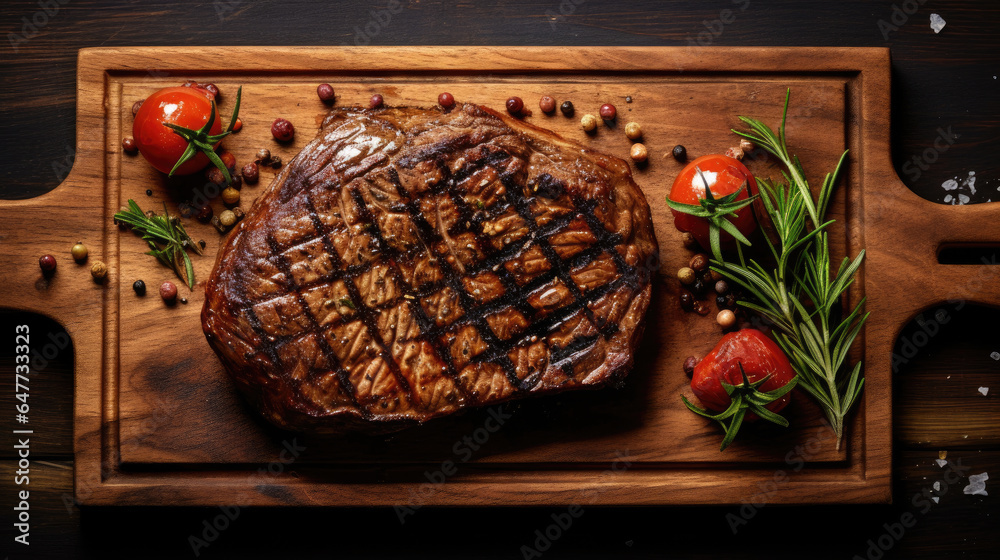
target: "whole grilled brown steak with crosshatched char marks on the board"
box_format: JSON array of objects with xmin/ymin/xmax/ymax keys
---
[{"xmin": 202, "ymin": 104, "xmax": 658, "ymax": 432}]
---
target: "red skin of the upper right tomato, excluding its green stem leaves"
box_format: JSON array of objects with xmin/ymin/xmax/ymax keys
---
[{"xmin": 670, "ymin": 154, "xmax": 757, "ymax": 249}]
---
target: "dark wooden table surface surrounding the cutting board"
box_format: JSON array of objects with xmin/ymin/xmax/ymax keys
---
[{"xmin": 0, "ymin": 0, "xmax": 1000, "ymax": 558}]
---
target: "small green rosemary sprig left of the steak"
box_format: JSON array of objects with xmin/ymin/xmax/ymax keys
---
[{"xmin": 114, "ymin": 198, "xmax": 202, "ymax": 290}]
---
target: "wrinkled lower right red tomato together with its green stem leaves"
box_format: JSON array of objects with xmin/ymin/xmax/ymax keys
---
[{"xmin": 681, "ymin": 329, "xmax": 796, "ymax": 449}]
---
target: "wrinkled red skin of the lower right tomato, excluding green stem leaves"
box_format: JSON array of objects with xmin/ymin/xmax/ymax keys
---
[{"xmin": 691, "ymin": 329, "xmax": 795, "ymax": 420}]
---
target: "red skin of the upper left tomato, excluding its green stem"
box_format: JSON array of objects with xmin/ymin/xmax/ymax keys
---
[{"xmin": 132, "ymin": 86, "xmax": 222, "ymax": 175}]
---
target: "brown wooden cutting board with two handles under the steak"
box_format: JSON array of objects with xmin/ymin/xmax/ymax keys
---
[{"xmin": 0, "ymin": 47, "xmax": 1000, "ymax": 507}]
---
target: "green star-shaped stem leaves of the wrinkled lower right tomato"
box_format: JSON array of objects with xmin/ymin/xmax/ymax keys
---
[{"xmin": 681, "ymin": 362, "xmax": 798, "ymax": 451}]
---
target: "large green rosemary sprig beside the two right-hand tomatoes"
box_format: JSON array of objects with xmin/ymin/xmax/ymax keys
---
[{"xmin": 712, "ymin": 90, "xmax": 868, "ymax": 449}]
